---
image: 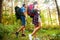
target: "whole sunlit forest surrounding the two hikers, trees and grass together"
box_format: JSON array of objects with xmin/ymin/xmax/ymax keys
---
[{"xmin": 0, "ymin": 0, "xmax": 60, "ymax": 40}]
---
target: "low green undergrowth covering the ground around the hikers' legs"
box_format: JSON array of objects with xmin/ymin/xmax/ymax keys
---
[{"xmin": 0, "ymin": 23, "xmax": 60, "ymax": 40}]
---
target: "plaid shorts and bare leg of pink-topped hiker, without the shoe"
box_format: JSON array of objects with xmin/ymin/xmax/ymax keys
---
[{"xmin": 32, "ymin": 14, "xmax": 41, "ymax": 36}]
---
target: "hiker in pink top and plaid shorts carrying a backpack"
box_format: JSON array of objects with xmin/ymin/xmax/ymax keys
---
[{"xmin": 28, "ymin": 2, "xmax": 41, "ymax": 40}]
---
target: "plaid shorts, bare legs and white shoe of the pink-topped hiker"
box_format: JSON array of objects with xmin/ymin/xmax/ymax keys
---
[{"xmin": 29, "ymin": 14, "xmax": 41, "ymax": 40}]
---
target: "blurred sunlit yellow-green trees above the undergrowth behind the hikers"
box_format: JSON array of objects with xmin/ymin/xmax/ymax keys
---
[{"xmin": 0, "ymin": 0, "xmax": 60, "ymax": 25}]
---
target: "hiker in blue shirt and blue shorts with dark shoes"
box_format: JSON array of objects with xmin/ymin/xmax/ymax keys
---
[{"xmin": 16, "ymin": 4, "xmax": 26, "ymax": 36}]
